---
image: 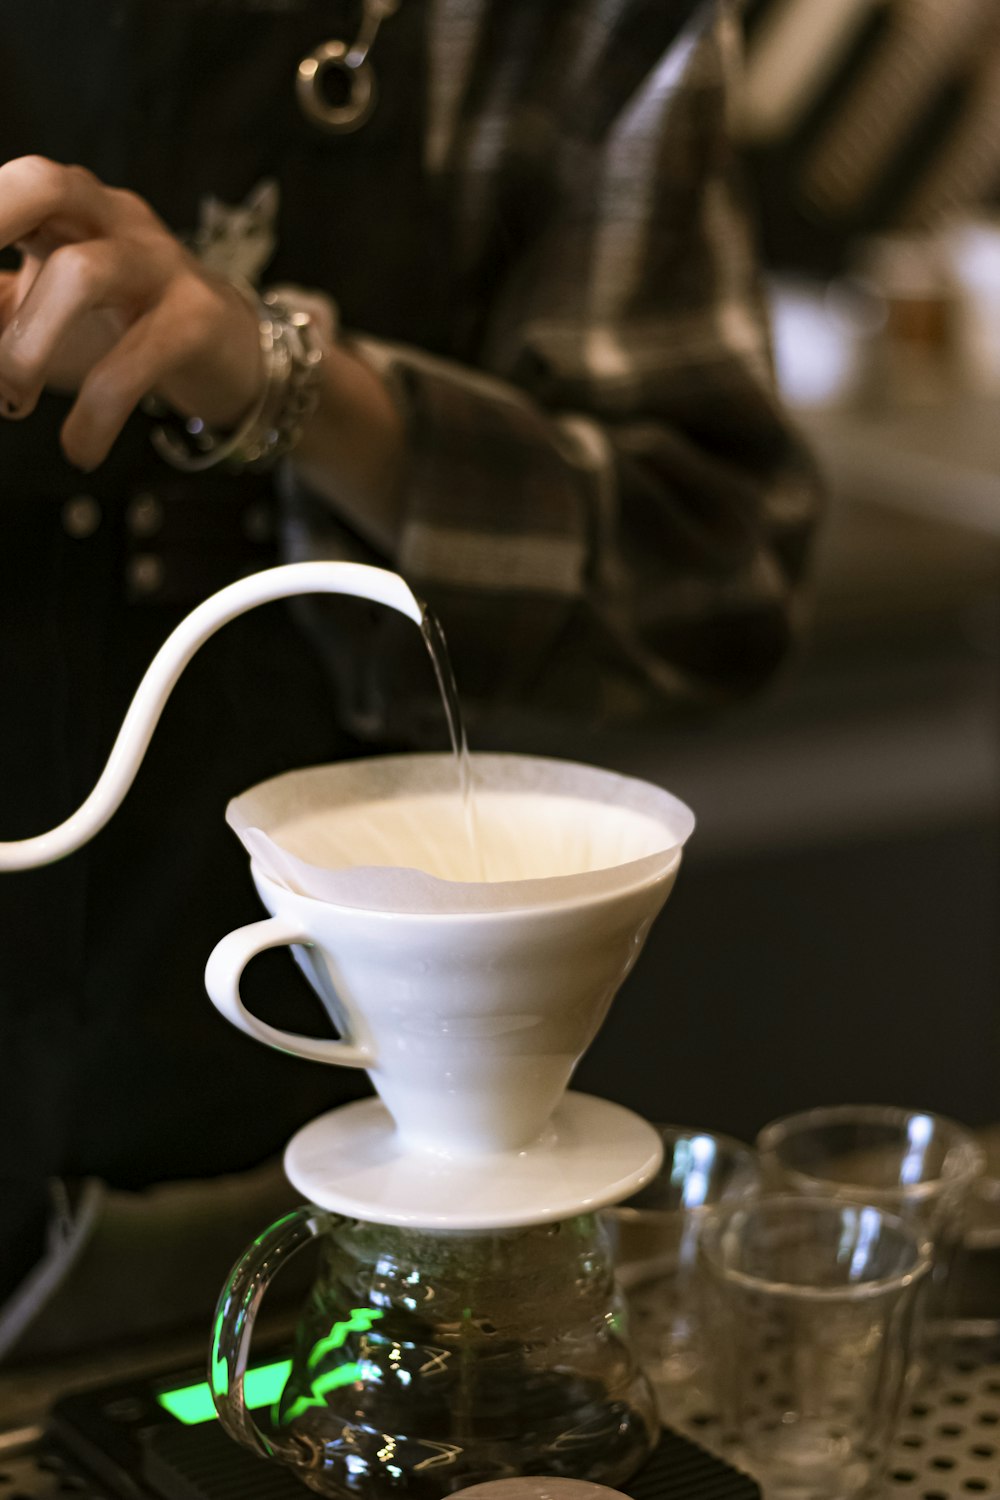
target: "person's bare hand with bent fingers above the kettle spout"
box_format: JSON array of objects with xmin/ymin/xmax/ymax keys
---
[{"xmin": 0, "ymin": 156, "xmax": 264, "ymax": 470}]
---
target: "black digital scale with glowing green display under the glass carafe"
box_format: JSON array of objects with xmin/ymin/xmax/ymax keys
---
[{"xmin": 0, "ymin": 1358, "xmax": 760, "ymax": 1500}]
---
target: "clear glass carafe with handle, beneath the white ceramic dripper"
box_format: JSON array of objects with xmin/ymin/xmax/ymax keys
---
[{"xmin": 211, "ymin": 1208, "xmax": 658, "ymax": 1500}]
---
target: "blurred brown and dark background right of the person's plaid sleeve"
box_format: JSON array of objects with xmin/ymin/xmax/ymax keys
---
[{"xmin": 577, "ymin": 0, "xmax": 1000, "ymax": 1137}]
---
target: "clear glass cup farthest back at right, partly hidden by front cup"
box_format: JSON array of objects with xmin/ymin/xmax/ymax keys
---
[{"xmin": 757, "ymin": 1104, "xmax": 985, "ymax": 1347}]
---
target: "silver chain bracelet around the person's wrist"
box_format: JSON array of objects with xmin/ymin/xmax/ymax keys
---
[{"xmin": 151, "ymin": 291, "xmax": 324, "ymax": 474}]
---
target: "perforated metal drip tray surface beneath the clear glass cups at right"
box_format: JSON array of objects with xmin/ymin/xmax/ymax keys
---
[{"xmin": 656, "ymin": 1334, "xmax": 1000, "ymax": 1500}]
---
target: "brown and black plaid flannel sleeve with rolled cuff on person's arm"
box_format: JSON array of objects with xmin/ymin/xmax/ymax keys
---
[{"xmin": 295, "ymin": 0, "xmax": 817, "ymax": 738}]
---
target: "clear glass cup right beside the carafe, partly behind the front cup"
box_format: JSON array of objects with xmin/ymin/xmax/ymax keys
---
[{"xmin": 604, "ymin": 1125, "xmax": 759, "ymax": 1424}]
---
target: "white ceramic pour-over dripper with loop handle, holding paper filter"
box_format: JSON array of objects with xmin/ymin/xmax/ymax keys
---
[{"xmin": 205, "ymin": 755, "xmax": 693, "ymax": 1229}]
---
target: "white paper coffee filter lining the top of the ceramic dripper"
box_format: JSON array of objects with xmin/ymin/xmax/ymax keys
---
[{"xmin": 226, "ymin": 755, "xmax": 694, "ymax": 912}]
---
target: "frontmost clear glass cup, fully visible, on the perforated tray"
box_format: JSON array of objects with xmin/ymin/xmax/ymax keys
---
[{"xmin": 699, "ymin": 1194, "xmax": 931, "ymax": 1500}]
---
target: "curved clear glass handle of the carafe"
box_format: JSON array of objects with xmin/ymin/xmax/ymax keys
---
[{"xmin": 208, "ymin": 1203, "xmax": 330, "ymax": 1466}]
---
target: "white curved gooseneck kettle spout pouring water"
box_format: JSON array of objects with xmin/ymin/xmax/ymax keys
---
[{"xmin": 0, "ymin": 561, "xmax": 423, "ymax": 872}]
